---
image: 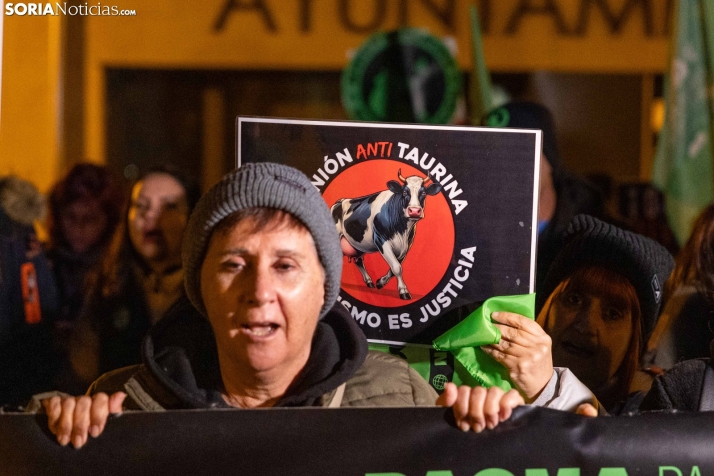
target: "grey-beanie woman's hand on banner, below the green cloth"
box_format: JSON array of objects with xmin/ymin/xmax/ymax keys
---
[{"xmin": 436, "ymin": 382, "xmax": 525, "ymax": 433}]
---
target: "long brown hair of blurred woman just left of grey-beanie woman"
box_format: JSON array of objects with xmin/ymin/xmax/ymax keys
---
[{"xmin": 90, "ymin": 165, "xmax": 200, "ymax": 297}]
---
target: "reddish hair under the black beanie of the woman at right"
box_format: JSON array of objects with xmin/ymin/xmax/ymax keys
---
[{"xmin": 536, "ymin": 266, "xmax": 643, "ymax": 408}]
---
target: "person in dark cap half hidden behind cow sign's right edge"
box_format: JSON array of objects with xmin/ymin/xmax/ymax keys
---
[{"xmin": 484, "ymin": 101, "xmax": 604, "ymax": 293}]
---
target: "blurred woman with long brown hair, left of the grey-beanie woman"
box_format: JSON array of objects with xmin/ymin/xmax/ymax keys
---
[{"xmin": 69, "ymin": 167, "xmax": 199, "ymax": 388}]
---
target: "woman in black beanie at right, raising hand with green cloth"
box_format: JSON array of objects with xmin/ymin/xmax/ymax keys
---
[{"xmin": 482, "ymin": 215, "xmax": 674, "ymax": 416}]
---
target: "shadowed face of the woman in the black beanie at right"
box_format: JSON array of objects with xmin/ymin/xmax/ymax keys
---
[{"xmin": 545, "ymin": 282, "xmax": 632, "ymax": 391}]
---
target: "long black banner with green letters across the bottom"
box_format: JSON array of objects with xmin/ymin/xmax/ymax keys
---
[{"xmin": 0, "ymin": 407, "xmax": 714, "ymax": 476}]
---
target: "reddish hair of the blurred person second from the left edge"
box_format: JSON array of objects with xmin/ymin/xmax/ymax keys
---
[{"xmin": 47, "ymin": 163, "xmax": 126, "ymax": 248}]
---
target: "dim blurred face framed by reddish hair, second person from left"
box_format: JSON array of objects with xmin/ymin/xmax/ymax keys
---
[{"xmin": 60, "ymin": 199, "xmax": 107, "ymax": 253}]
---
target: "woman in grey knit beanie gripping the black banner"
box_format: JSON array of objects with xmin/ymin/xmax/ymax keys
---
[{"xmin": 30, "ymin": 163, "xmax": 523, "ymax": 447}]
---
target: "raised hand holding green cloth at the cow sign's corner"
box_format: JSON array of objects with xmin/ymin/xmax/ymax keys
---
[{"xmin": 481, "ymin": 312, "xmax": 553, "ymax": 402}]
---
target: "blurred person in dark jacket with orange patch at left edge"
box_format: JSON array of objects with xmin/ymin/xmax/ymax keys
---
[{"xmin": 0, "ymin": 176, "xmax": 59, "ymax": 405}]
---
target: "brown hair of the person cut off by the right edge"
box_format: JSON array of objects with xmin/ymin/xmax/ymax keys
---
[{"xmin": 664, "ymin": 203, "xmax": 714, "ymax": 306}]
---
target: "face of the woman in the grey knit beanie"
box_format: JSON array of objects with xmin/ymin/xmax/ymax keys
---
[{"xmin": 201, "ymin": 219, "xmax": 325, "ymax": 380}]
